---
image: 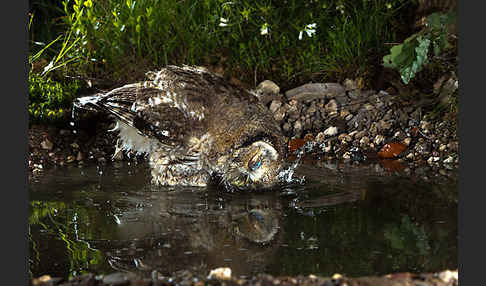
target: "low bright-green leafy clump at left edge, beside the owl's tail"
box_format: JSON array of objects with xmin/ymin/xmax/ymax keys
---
[{"xmin": 29, "ymin": 72, "xmax": 80, "ymax": 123}]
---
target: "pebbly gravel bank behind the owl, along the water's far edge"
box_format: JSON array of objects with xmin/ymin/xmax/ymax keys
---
[{"xmin": 28, "ymin": 76, "xmax": 459, "ymax": 181}]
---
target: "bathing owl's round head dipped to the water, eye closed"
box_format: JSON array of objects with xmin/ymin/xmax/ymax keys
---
[{"xmin": 223, "ymin": 140, "xmax": 283, "ymax": 190}]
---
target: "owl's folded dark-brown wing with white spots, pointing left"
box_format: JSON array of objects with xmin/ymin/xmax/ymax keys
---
[{"xmin": 75, "ymin": 82, "xmax": 203, "ymax": 160}]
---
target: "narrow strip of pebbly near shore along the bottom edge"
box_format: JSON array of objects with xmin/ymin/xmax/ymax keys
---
[{"xmin": 30, "ymin": 270, "xmax": 459, "ymax": 286}]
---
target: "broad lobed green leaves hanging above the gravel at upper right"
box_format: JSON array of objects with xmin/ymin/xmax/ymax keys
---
[{"xmin": 383, "ymin": 12, "xmax": 456, "ymax": 84}]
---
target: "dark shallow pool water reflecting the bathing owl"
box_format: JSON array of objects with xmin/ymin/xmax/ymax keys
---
[{"xmin": 29, "ymin": 161, "xmax": 458, "ymax": 277}]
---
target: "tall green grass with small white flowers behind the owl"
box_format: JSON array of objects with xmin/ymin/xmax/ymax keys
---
[{"xmin": 57, "ymin": 0, "xmax": 410, "ymax": 87}]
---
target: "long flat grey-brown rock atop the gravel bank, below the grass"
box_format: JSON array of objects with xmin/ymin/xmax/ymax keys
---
[{"xmin": 285, "ymin": 83, "xmax": 345, "ymax": 101}]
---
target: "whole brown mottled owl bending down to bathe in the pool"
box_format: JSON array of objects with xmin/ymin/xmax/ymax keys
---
[{"xmin": 75, "ymin": 66, "xmax": 286, "ymax": 190}]
